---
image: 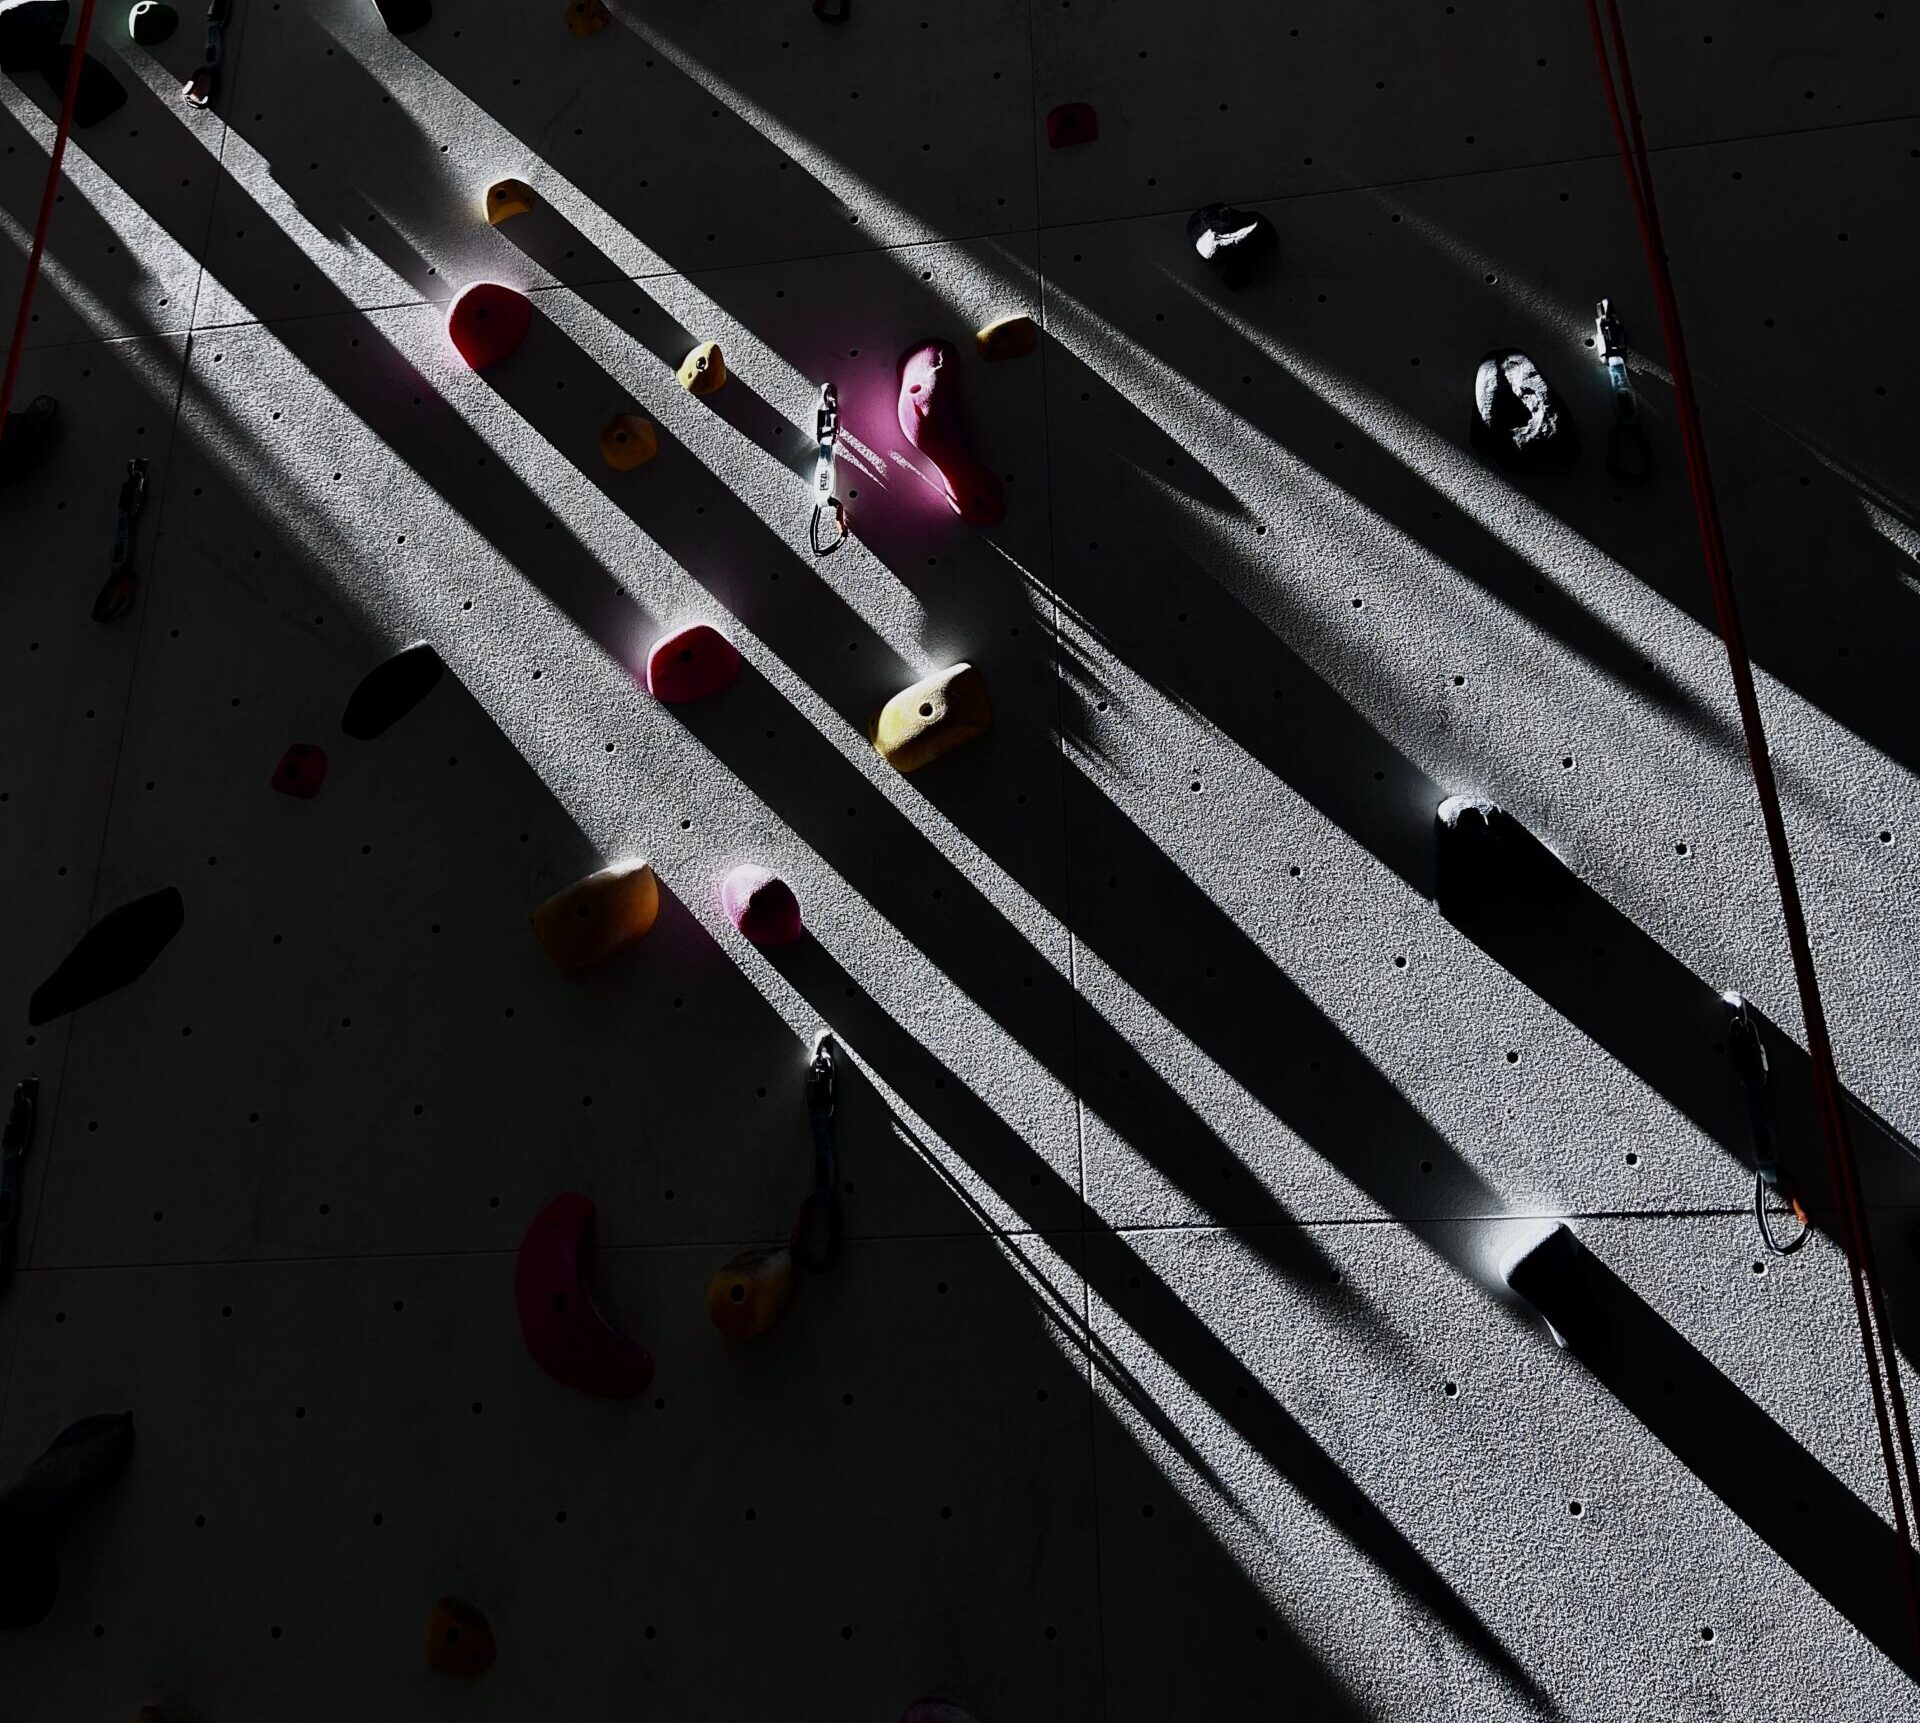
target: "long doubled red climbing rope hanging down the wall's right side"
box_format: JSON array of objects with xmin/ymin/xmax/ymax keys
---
[{"xmin": 1586, "ymin": 0, "xmax": 1920, "ymax": 1648}]
